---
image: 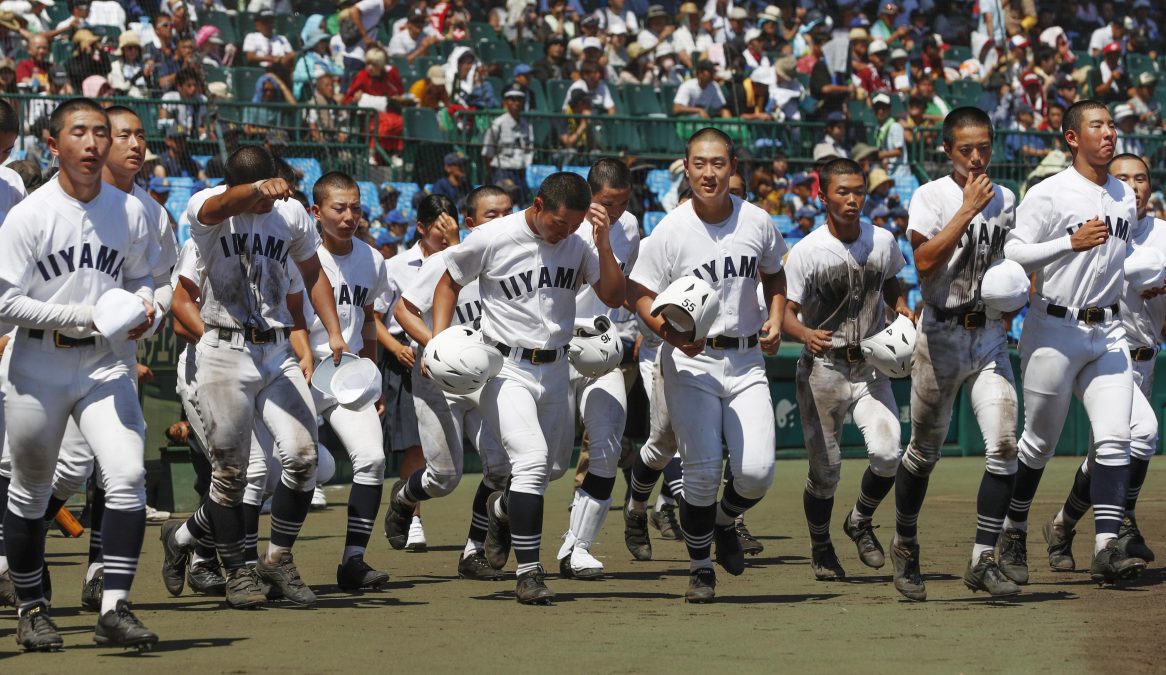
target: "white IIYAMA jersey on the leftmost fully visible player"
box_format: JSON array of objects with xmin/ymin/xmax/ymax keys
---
[{"xmin": 0, "ymin": 178, "xmax": 159, "ymax": 338}]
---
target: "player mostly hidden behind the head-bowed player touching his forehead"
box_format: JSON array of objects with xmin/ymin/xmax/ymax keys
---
[{"xmin": 389, "ymin": 185, "xmax": 514, "ymax": 581}]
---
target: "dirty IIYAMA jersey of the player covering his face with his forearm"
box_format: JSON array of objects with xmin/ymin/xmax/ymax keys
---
[{"xmin": 187, "ymin": 185, "xmax": 319, "ymax": 330}]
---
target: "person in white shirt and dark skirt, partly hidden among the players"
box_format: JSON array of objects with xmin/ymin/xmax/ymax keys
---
[{"xmin": 377, "ymin": 195, "xmax": 458, "ymax": 553}]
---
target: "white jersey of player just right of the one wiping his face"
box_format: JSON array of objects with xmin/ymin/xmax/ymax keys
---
[{"xmin": 303, "ymin": 238, "xmax": 388, "ymax": 359}]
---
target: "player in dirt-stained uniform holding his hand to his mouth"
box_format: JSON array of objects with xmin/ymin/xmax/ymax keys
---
[{"xmin": 891, "ymin": 107, "xmax": 1019, "ymax": 600}]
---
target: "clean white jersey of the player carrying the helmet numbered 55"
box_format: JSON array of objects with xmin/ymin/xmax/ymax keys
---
[{"xmin": 631, "ymin": 197, "xmax": 786, "ymax": 337}]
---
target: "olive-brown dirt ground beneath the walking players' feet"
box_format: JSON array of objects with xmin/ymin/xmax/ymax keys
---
[{"xmin": 0, "ymin": 458, "xmax": 1166, "ymax": 675}]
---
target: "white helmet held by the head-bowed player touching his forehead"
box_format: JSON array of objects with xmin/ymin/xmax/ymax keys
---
[{"xmin": 423, "ymin": 325, "xmax": 503, "ymax": 396}]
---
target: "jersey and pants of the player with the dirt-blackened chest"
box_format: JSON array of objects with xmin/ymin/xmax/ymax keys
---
[{"xmin": 786, "ymin": 223, "xmax": 906, "ymax": 499}]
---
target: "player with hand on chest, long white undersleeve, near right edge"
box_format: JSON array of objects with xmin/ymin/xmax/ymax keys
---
[{"xmin": 997, "ymin": 99, "xmax": 1146, "ymax": 585}]
